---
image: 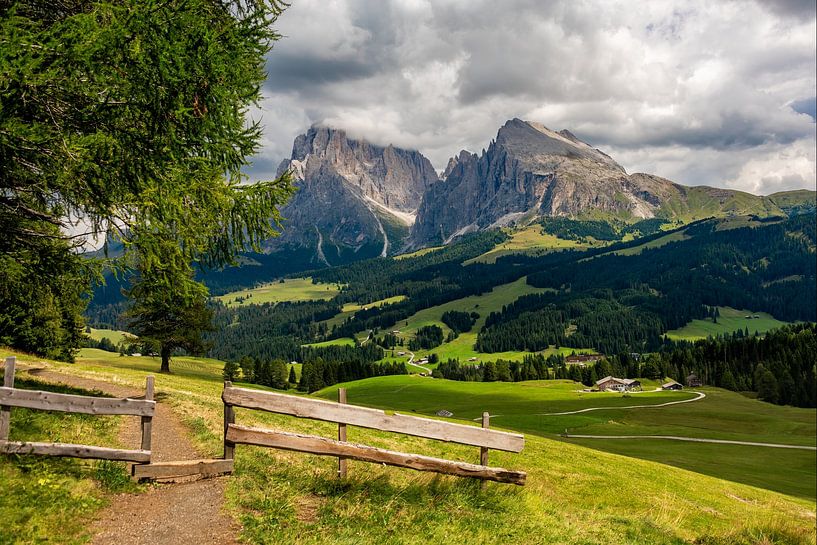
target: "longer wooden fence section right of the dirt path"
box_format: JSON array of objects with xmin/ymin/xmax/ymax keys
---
[{"xmin": 222, "ymin": 382, "xmax": 526, "ymax": 485}]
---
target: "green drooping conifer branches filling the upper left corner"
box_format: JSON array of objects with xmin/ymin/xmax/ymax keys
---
[{"xmin": 0, "ymin": 0, "xmax": 292, "ymax": 359}]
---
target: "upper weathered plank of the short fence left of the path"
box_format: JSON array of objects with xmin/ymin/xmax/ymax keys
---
[{"xmin": 0, "ymin": 387, "xmax": 156, "ymax": 416}]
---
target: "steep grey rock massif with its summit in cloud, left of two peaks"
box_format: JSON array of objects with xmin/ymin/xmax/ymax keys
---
[{"xmin": 267, "ymin": 126, "xmax": 438, "ymax": 266}]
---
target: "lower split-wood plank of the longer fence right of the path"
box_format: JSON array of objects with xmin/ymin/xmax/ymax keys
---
[{"xmin": 227, "ymin": 424, "xmax": 527, "ymax": 485}]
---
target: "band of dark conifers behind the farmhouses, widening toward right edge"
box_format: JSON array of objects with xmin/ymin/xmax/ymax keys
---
[{"xmin": 433, "ymin": 324, "xmax": 817, "ymax": 407}]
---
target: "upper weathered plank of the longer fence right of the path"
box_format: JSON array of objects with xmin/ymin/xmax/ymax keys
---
[{"xmin": 222, "ymin": 387, "xmax": 525, "ymax": 452}]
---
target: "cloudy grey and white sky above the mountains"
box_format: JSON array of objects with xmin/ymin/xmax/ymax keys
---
[{"xmin": 247, "ymin": 0, "xmax": 817, "ymax": 194}]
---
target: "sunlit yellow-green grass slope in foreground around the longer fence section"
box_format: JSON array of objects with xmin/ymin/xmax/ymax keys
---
[{"xmin": 3, "ymin": 350, "xmax": 815, "ymax": 545}]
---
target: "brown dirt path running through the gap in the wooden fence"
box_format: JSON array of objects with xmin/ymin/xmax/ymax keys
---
[{"xmin": 29, "ymin": 369, "xmax": 239, "ymax": 545}]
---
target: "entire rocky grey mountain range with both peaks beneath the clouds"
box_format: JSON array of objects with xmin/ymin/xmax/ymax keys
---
[{"xmin": 265, "ymin": 119, "xmax": 815, "ymax": 262}]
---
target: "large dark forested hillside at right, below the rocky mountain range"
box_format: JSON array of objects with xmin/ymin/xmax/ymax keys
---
[{"xmin": 477, "ymin": 210, "xmax": 817, "ymax": 354}]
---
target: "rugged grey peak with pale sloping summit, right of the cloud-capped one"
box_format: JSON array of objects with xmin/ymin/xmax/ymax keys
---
[{"xmin": 412, "ymin": 119, "xmax": 681, "ymax": 244}]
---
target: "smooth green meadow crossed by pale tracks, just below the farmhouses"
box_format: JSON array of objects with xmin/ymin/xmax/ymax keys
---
[{"xmin": 316, "ymin": 376, "xmax": 817, "ymax": 500}]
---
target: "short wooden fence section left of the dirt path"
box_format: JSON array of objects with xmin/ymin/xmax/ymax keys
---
[{"xmin": 0, "ymin": 357, "xmax": 156, "ymax": 463}]
